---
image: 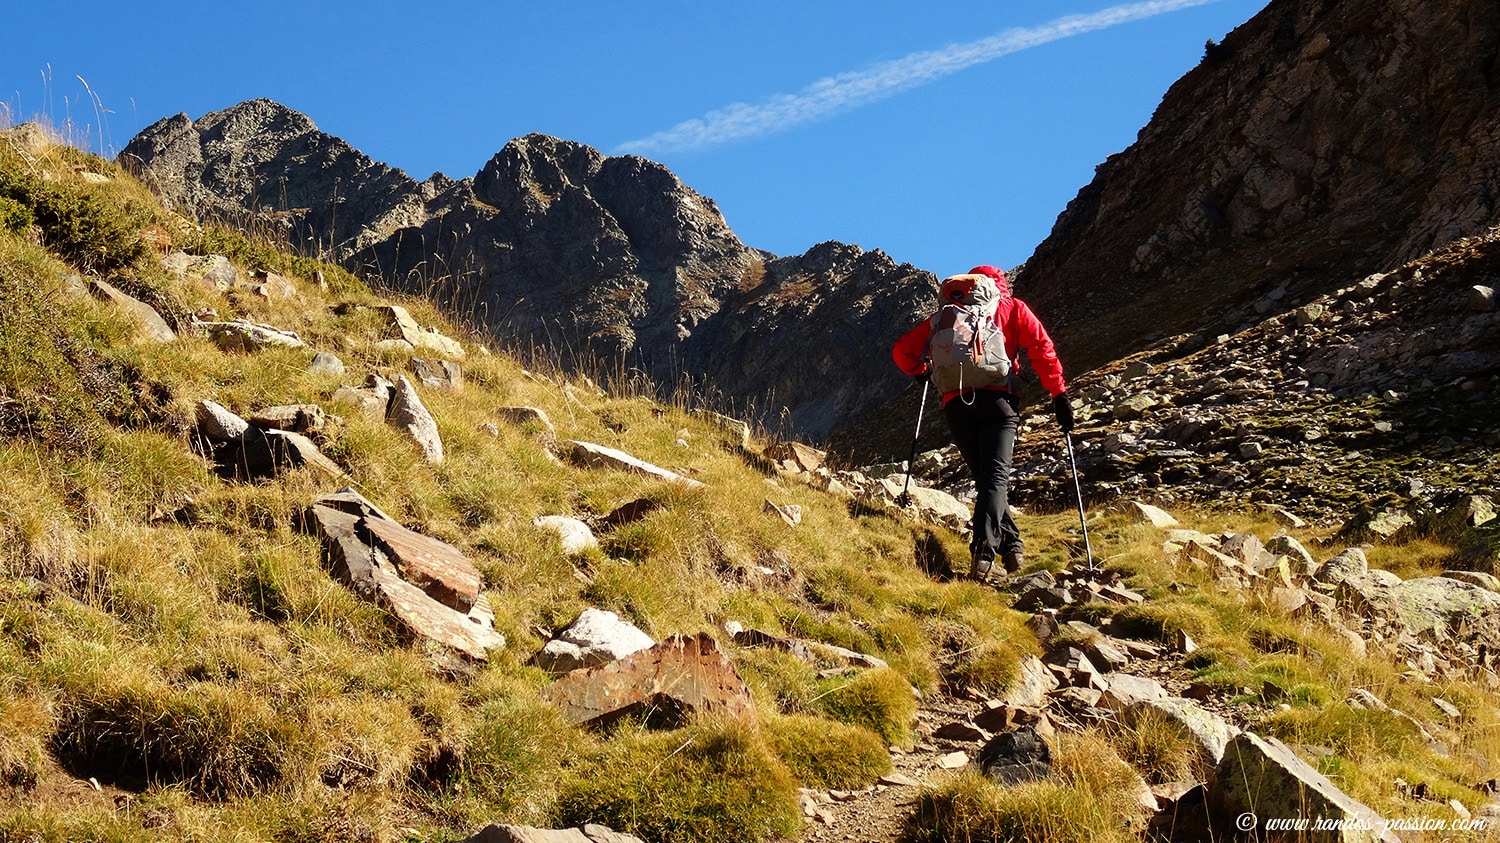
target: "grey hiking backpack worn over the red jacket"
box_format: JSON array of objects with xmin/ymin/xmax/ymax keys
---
[{"xmin": 927, "ymin": 275, "xmax": 1011, "ymax": 393}]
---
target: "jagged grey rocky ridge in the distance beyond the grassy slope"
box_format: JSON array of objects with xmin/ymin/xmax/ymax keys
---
[{"xmin": 122, "ymin": 101, "xmax": 933, "ymax": 438}]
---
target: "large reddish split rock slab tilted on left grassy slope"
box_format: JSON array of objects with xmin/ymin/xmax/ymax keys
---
[{"xmin": 302, "ymin": 489, "xmax": 506, "ymax": 662}]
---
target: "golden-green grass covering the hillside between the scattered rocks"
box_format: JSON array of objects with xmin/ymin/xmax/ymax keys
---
[{"xmin": 0, "ymin": 124, "xmax": 1500, "ymax": 842}]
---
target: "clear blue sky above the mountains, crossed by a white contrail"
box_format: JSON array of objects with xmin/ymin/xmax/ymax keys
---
[{"xmin": 0, "ymin": 0, "xmax": 1265, "ymax": 275}]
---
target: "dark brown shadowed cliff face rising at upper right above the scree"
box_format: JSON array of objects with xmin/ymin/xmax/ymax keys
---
[{"xmin": 1020, "ymin": 0, "xmax": 1500, "ymax": 371}]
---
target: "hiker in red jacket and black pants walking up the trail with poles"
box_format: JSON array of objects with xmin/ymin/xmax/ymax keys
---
[{"xmin": 891, "ymin": 266, "xmax": 1073, "ymax": 582}]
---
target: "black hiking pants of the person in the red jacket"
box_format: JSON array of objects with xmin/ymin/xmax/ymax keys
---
[{"xmin": 942, "ymin": 390, "xmax": 1022, "ymax": 560}]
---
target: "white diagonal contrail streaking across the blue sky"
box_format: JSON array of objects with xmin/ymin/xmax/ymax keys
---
[{"xmin": 615, "ymin": 0, "xmax": 1217, "ymax": 155}]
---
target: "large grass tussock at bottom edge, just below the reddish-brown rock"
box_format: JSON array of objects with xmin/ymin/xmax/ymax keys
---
[{"xmin": 557, "ymin": 714, "xmax": 803, "ymax": 843}]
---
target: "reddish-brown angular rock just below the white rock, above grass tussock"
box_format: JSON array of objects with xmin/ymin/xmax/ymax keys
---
[{"xmin": 542, "ymin": 635, "xmax": 756, "ymax": 728}]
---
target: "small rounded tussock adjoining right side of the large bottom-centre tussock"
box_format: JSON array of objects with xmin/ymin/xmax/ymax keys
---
[{"xmin": 762, "ymin": 716, "xmax": 891, "ymax": 791}]
